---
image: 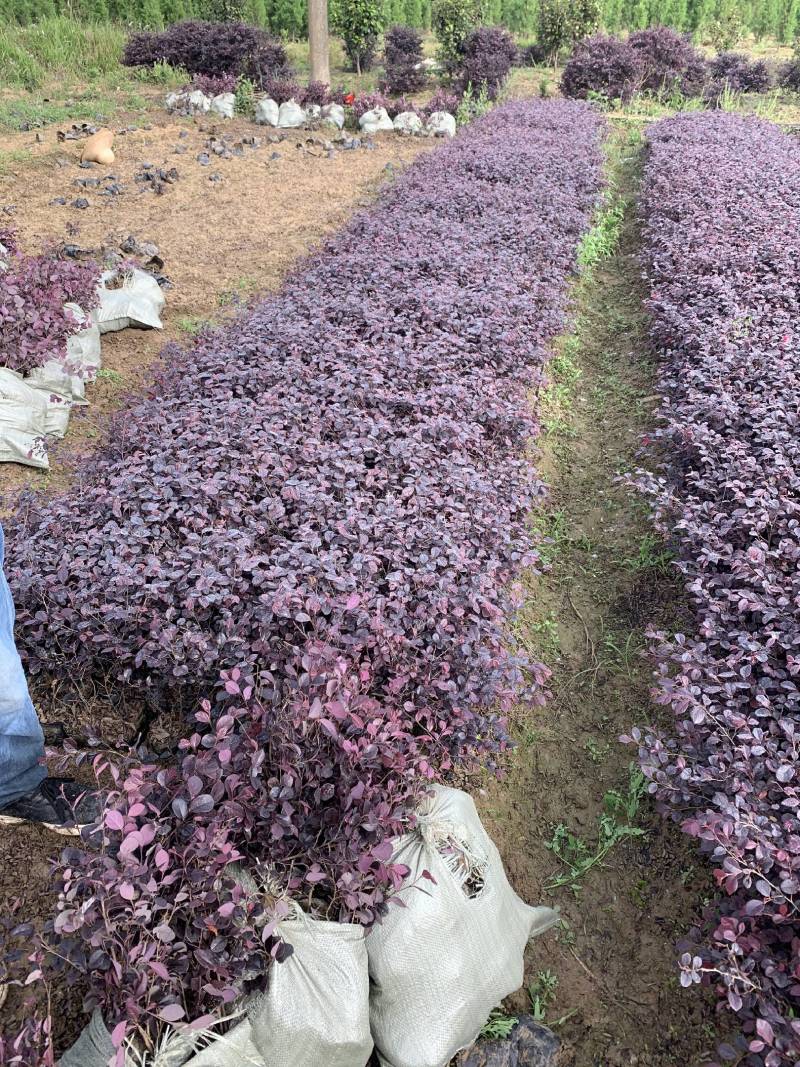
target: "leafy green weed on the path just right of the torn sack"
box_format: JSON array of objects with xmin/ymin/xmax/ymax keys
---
[{"xmin": 545, "ymin": 764, "xmax": 646, "ymax": 896}]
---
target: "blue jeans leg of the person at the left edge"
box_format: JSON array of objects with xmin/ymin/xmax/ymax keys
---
[{"xmin": 0, "ymin": 563, "xmax": 47, "ymax": 808}]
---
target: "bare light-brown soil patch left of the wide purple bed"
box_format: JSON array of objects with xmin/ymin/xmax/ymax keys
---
[{"xmin": 0, "ymin": 112, "xmax": 432, "ymax": 501}]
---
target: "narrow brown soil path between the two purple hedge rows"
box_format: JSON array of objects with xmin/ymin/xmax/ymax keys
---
[{"xmin": 462, "ymin": 133, "xmax": 717, "ymax": 1067}]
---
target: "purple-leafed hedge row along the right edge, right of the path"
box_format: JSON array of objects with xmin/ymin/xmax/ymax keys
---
[{"xmin": 636, "ymin": 113, "xmax": 800, "ymax": 1067}]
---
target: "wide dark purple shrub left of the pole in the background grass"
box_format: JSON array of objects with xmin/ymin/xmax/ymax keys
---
[{"xmin": 122, "ymin": 19, "xmax": 291, "ymax": 84}]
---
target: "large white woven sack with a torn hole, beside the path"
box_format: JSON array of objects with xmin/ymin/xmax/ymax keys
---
[{"xmin": 367, "ymin": 785, "xmax": 559, "ymax": 1067}]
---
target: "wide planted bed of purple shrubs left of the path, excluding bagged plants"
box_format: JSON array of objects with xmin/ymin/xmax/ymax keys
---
[{"xmin": 7, "ymin": 102, "xmax": 599, "ymax": 725}]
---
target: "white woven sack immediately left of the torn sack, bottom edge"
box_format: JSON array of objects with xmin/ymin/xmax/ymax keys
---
[{"xmin": 187, "ymin": 912, "xmax": 372, "ymax": 1067}]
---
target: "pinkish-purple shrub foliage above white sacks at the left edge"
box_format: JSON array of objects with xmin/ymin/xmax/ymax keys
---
[{"xmin": 0, "ymin": 244, "xmax": 100, "ymax": 375}]
